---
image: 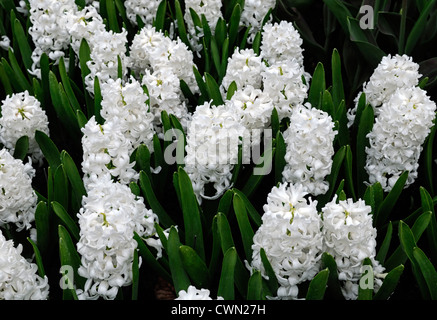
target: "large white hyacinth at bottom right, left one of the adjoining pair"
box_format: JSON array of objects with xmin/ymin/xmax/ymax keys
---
[{"xmin": 250, "ymin": 183, "xmax": 323, "ymax": 299}]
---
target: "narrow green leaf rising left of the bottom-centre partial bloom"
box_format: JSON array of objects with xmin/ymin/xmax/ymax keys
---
[{"xmin": 167, "ymin": 226, "xmax": 191, "ymax": 294}]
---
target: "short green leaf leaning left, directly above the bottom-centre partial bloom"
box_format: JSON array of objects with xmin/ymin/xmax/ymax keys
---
[{"xmin": 179, "ymin": 245, "xmax": 210, "ymax": 288}]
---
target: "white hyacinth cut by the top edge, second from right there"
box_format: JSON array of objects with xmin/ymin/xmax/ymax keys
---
[{"xmin": 184, "ymin": 0, "xmax": 223, "ymax": 51}]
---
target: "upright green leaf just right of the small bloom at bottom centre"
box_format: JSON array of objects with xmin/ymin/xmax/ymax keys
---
[{"xmin": 217, "ymin": 247, "xmax": 237, "ymax": 300}]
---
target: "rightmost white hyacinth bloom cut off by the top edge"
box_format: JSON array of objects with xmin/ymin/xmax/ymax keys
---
[{"xmin": 240, "ymin": 0, "xmax": 276, "ymax": 42}]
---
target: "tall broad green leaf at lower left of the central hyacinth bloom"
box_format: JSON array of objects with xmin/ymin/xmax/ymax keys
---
[{"xmin": 178, "ymin": 168, "xmax": 205, "ymax": 259}]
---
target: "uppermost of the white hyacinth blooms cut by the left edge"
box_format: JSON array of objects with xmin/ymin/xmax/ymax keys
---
[{"xmin": 0, "ymin": 90, "xmax": 49, "ymax": 163}]
